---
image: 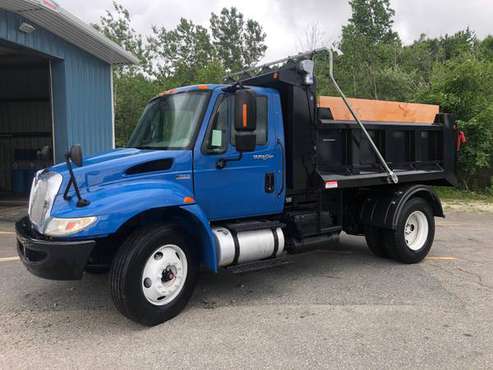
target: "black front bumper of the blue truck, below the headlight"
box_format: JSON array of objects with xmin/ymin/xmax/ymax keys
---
[{"xmin": 15, "ymin": 217, "xmax": 96, "ymax": 280}]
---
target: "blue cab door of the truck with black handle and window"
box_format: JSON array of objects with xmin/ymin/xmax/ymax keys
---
[{"xmin": 194, "ymin": 94, "xmax": 284, "ymax": 220}]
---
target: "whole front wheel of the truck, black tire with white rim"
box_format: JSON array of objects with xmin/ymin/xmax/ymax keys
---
[{"xmin": 110, "ymin": 225, "xmax": 199, "ymax": 326}]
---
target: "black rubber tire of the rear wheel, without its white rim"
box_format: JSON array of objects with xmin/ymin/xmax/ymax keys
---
[{"xmin": 385, "ymin": 198, "xmax": 435, "ymax": 264}]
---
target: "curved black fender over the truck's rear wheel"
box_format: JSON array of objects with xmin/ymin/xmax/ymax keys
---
[{"xmin": 360, "ymin": 185, "xmax": 445, "ymax": 230}]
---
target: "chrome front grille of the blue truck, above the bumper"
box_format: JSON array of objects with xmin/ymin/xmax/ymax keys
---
[{"xmin": 29, "ymin": 172, "xmax": 63, "ymax": 232}]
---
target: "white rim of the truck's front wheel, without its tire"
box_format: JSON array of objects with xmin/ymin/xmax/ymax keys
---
[{"xmin": 141, "ymin": 244, "xmax": 188, "ymax": 306}]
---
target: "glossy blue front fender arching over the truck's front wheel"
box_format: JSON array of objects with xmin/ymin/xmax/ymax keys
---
[{"xmin": 52, "ymin": 180, "xmax": 218, "ymax": 272}]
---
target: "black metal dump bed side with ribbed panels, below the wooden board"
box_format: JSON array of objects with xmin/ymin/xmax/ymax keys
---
[{"xmin": 317, "ymin": 112, "xmax": 457, "ymax": 188}]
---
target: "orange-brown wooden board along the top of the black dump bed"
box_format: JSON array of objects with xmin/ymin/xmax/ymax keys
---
[{"xmin": 319, "ymin": 96, "xmax": 440, "ymax": 124}]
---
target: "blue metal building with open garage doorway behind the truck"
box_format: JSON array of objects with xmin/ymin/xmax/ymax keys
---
[{"xmin": 0, "ymin": 0, "xmax": 138, "ymax": 196}]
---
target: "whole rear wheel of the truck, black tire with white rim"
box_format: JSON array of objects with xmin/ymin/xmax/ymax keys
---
[{"xmin": 385, "ymin": 198, "xmax": 435, "ymax": 264}]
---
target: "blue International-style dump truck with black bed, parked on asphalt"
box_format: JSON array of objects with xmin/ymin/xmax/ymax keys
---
[{"xmin": 16, "ymin": 51, "xmax": 458, "ymax": 326}]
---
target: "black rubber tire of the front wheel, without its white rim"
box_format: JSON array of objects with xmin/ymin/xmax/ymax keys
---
[{"xmin": 110, "ymin": 225, "xmax": 199, "ymax": 326}]
